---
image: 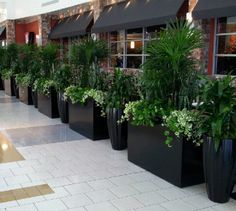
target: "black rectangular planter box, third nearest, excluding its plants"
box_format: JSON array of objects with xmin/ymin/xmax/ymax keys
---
[{"xmin": 38, "ymin": 89, "xmax": 59, "ymax": 118}]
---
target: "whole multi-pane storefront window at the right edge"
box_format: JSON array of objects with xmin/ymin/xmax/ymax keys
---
[{"xmin": 215, "ymin": 17, "xmax": 236, "ymax": 75}]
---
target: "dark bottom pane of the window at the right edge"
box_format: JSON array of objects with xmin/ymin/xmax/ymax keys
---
[{"xmin": 216, "ymin": 57, "xmax": 236, "ymax": 75}]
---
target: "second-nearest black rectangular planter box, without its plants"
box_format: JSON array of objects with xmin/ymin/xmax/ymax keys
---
[{"xmin": 69, "ymin": 100, "xmax": 109, "ymax": 141}]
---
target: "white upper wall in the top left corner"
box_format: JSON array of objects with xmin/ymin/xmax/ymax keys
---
[{"xmin": 0, "ymin": 0, "xmax": 91, "ymax": 21}]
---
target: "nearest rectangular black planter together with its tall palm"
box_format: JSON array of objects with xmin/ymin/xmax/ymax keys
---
[{"xmin": 124, "ymin": 21, "xmax": 204, "ymax": 187}]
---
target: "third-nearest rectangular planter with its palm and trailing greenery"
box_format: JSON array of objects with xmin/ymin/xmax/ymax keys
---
[{"xmin": 34, "ymin": 43, "xmax": 59, "ymax": 118}]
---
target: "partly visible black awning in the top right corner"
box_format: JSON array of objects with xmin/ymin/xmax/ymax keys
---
[{"xmin": 193, "ymin": 0, "xmax": 236, "ymax": 19}]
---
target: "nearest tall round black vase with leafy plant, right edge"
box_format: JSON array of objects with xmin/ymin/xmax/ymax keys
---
[{"xmin": 199, "ymin": 75, "xmax": 236, "ymax": 203}]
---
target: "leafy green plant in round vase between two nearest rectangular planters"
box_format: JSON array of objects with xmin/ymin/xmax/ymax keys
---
[{"xmin": 105, "ymin": 69, "xmax": 135, "ymax": 108}]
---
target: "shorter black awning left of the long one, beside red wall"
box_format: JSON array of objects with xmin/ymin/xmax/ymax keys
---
[{"xmin": 49, "ymin": 12, "xmax": 93, "ymax": 39}]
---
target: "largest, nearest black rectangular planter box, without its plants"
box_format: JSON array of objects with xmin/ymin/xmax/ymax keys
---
[{"xmin": 128, "ymin": 125, "xmax": 204, "ymax": 187}]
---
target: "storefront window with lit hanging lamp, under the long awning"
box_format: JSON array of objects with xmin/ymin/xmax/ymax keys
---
[{"xmin": 109, "ymin": 25, "xmax": 165, "ymax": 69}]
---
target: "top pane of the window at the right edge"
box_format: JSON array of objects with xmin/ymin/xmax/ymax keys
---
[{"xmin": 218, "ymin": 17, "xmax": 236, "ymax": 33}]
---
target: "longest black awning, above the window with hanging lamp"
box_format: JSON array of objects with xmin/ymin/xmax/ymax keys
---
[{"xmin": 92, "ymin": 0, "xmax": 185, "ymax": 33}]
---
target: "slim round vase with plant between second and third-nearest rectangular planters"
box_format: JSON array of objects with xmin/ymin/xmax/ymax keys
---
[{"xmin": 53, "ymin": 64, "xmax": 72, "ymax": 123}]
